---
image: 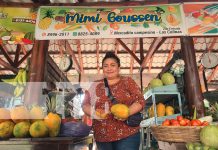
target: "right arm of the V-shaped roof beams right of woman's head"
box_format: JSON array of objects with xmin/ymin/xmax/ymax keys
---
[{"xmin": 141, "ymin": 37, "xmax": 166, "ymax": 70}]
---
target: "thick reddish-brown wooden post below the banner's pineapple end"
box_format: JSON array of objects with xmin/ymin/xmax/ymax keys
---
[{"xmin": 24, "ymin": 40, "xmax": 49, "ymax": 105}]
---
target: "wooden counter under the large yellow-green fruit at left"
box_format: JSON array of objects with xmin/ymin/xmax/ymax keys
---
[{"xmin": 0, "ymin": 135, "xmax": 93, "ymax": 150}]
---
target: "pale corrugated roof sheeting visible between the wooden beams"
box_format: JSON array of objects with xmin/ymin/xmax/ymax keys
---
[{"xmin": 0, "ymin": 37, "xmax": 218, "ymax": 83}]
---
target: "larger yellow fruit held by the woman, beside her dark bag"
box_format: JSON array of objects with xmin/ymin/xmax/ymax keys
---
[{"xmin": 111, "ymin": 104, "xmax": 129, "ymax": 119}]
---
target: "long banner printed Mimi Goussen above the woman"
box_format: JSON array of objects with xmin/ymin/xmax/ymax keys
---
[{"xmin": 36, "ymin": 4, "xmax": 185, "ymax": 40}]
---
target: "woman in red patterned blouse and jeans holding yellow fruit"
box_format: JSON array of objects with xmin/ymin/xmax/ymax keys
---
[{"xmin": 83, "ymin": 52, "xmax": 145, "ymax": 150}]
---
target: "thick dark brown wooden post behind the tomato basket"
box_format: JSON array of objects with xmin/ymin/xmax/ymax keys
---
[{"xmin": 181, "ymin": 37, "xmax": 204, "ymax": 118}]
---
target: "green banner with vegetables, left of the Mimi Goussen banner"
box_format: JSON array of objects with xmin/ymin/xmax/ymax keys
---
[{"xmin": 0, "ymin": 7, "xmax": 37, "ymax": 44}]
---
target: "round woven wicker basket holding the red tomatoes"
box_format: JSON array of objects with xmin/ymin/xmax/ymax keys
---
[{"xmin": 151, "ymin": 126, "xmax": 203, "ymax": 142}]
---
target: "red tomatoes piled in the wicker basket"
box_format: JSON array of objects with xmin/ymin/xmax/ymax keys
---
[{"xmin": 162, "ymin": 116, "xmax": 210, "ymax": 126}]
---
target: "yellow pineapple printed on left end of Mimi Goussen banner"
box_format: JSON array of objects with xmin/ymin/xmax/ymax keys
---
[{"xmin": 38, "ymin": 9, "xmax": 54, "ymax": 30}]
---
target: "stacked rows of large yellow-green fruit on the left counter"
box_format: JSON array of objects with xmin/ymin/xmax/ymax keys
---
[{"xmin": 0, "ymin": 99, "xmax": 61, "ymax": 139}]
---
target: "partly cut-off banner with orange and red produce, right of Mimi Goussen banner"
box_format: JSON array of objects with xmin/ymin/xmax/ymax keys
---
[{"xmin": 183, "ymin": 2, "xmax": 218, "ymax": 36}]
